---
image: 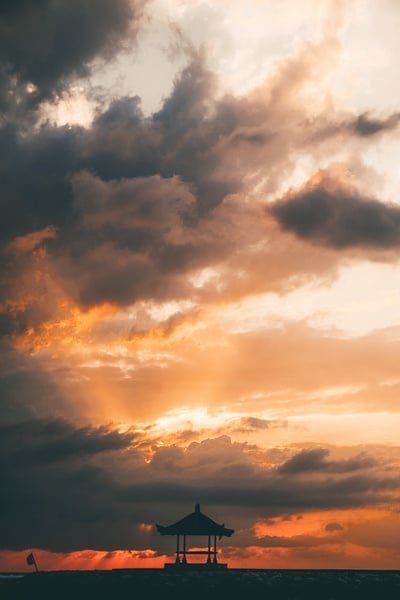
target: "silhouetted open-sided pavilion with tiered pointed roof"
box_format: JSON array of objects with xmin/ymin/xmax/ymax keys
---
[{"xmin": 156, "ymin": 504, "xmax": 234, "ymax": 567}]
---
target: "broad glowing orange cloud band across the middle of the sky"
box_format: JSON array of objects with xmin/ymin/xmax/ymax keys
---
[{"xmin": 18, "ymin": 318, "xmax": 399, "ymax": 426}]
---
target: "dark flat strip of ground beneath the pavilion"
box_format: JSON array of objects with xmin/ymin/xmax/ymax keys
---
[{"xmin": 0, "ymin": 569, "xmax": 400, "ymax": 600}]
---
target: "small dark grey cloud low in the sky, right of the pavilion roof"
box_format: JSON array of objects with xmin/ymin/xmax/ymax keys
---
[{"xmin": 278, "ymin": 448, "xmax": 377, "ymax": 475}]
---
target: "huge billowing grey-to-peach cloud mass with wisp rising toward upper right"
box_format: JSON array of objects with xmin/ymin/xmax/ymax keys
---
[{"xmin": 0, "ymin": 37, "xmax": 382, "ymax": 334}]
